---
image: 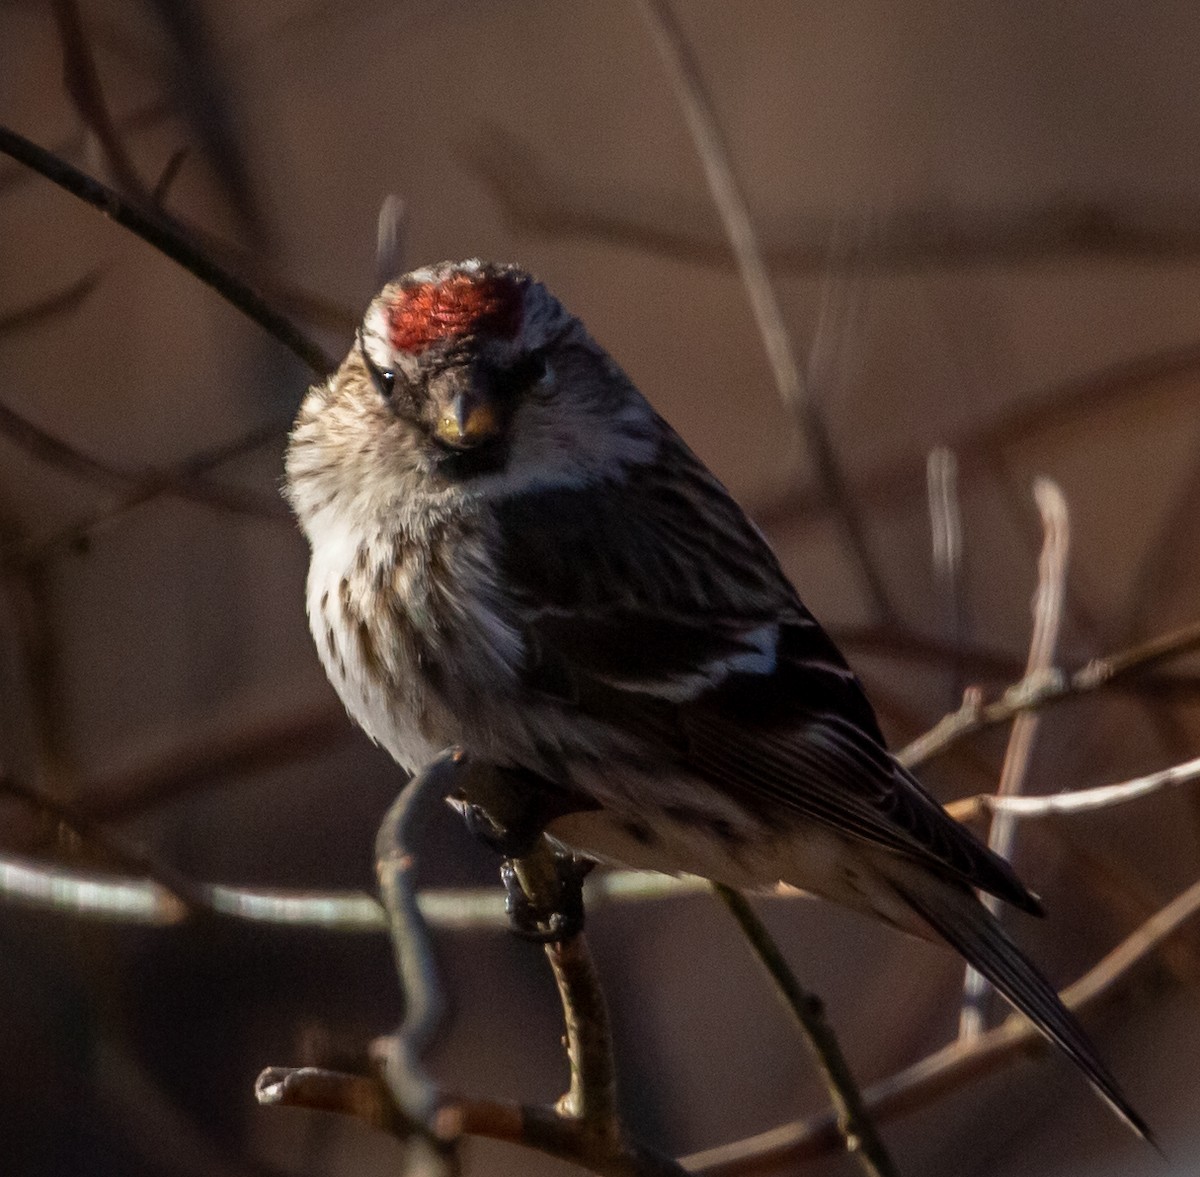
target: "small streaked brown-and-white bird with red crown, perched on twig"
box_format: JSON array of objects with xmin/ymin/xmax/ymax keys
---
[{"xmin": 286, "ymin": 259, "xmax": 1151, "ymax": 1140}]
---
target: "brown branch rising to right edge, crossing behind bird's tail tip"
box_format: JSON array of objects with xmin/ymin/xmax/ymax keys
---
[{"xmin": 682, "ymin": 868, "xmax": 1200, "ymax": 1177}]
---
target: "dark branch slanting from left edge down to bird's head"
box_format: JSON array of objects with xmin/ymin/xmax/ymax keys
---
[{"xmin": 0, "ymin": 126, "xmax": 336, "ymax": 376}]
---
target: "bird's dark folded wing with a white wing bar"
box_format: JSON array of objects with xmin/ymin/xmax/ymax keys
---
[{"xmin": 496, "ymin": 427, "xmax": 1037, "ymax": 909}]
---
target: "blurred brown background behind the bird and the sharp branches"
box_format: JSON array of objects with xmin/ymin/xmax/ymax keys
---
[{"xmin": 0, "ymin": 0, "xmax": 1200, "ymax": 1177}]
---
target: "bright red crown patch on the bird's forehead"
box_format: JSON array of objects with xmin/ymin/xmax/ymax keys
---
[{"xmin": 388, "ymin": 274, "xmax": 522, "ymax": 353}]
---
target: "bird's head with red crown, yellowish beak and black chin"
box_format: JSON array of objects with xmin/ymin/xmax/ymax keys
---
[{"xmin": 288, "ymin": 260, "xmax": 658, "ymax": 520}]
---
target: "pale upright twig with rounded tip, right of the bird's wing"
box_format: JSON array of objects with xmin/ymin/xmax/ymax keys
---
[{"xmin": 959, "ymin": 479, "xmax": 1070, "ymax": 1038}]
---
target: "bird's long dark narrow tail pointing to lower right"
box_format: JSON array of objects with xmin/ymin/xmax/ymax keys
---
[{"xmin": 889, "ymin": 871, "xmax": 1158, "ymax": 1148}]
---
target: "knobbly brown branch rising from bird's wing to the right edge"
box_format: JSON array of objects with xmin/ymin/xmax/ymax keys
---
[{"xmin": 896, "ymin": 621, "xmax": 1200, "ymax": 768}]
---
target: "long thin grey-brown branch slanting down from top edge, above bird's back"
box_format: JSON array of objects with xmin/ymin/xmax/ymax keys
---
[{"xmin": 641, "ymin": 0, "xmax": 896, "ymax": 620}]
